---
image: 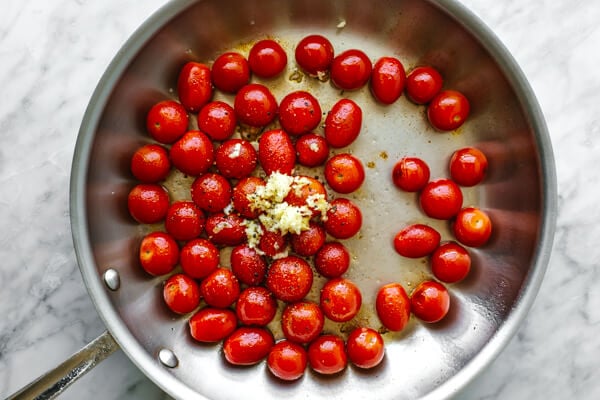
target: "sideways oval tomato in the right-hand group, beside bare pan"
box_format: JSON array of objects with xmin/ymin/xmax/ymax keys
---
[{"xmin": 394, "ymin": 224, "xmax": 441, "ymax": 258}]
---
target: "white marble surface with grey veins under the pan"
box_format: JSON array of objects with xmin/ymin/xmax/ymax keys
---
[{"xmin": 0, "ymin": 0, "xmax": 600, "ymax": 400}]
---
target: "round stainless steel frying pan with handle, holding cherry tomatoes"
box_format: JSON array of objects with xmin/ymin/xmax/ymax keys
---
[{"xmin": 12, "ymin": 0, "xmax": 556, "ymax": 399}]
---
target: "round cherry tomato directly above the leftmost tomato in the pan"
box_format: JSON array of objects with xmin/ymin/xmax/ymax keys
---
[{"xmin": 131, "ymin": 144, "xmax": 171, "ymax": 183}]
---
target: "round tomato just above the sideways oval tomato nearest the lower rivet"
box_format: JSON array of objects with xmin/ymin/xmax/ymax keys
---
[{"xmin": 200, "ymin": 268, "xmax": 240, "ymax": 308}]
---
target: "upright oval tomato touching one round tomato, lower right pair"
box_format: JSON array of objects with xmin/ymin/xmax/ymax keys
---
[{"xmin": 375, "ymin": 283, "xmax": 410, "ymax": 332}]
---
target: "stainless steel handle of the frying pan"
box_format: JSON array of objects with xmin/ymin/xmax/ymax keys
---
[{"xmin": 7, "ymin": 331, "xmax": 119, "ymax": 400}]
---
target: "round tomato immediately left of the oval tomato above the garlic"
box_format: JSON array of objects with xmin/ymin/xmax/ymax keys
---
[{"xmin": 215, "ymin": 139, "xmax": 258, "ymax": 179}]
